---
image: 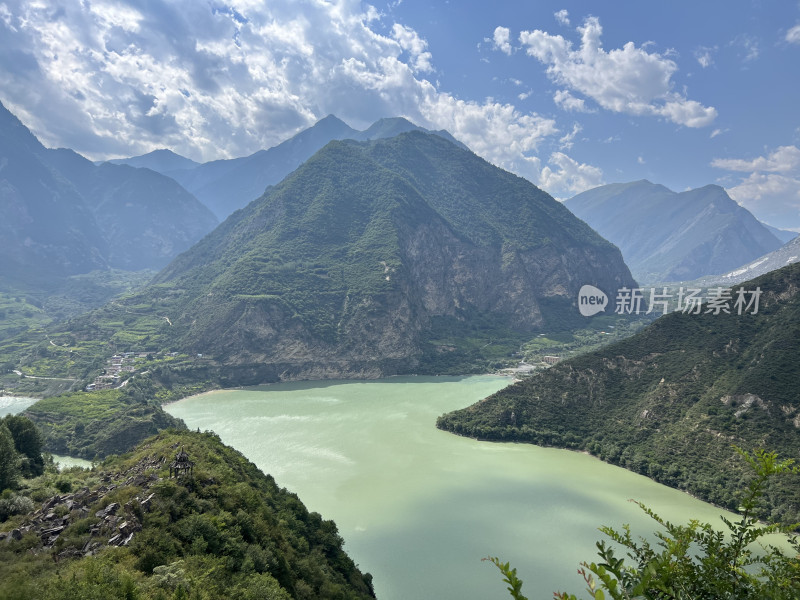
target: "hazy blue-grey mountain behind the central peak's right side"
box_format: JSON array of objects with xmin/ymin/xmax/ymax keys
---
[{"xmin": 565, "ymin": 180, "xmax": 781, "ymax": 284}]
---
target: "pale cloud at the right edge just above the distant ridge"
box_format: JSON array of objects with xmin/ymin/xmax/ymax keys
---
[{"xmin": 711, "ymin": 146, "xmax": 800, "ymax": 229}]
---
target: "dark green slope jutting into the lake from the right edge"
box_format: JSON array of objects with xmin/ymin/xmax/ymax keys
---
[{"xmin": 437, "ymin": 264, "xmax": 800, "ymax": 523}]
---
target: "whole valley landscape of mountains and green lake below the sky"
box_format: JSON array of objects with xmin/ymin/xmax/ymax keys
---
[{"xmin": 0, "ymin": 50, "xmax": 800, "ymax": 600}]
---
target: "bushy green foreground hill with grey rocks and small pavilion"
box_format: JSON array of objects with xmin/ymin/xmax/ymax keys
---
[{"xmin": 0, "ymin": 431, "xmax": 375, "ymax": 600}]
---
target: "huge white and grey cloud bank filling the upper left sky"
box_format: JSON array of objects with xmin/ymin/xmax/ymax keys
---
[{"xmin": 0, "ymin": 0, "xmax": 559, "ymax": 181}]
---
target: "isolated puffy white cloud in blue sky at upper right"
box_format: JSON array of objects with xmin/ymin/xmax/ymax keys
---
[{"xmin": 520, "ymin": 17, "xmax": 717, "ymax": 127}]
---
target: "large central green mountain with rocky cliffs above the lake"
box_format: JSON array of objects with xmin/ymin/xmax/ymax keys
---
[{"xmin": 79, "ymin": 131, "xmax": 633, "ymax": 382}]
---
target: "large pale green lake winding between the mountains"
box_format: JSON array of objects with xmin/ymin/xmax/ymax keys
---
[{"xmin": 165, "ymin": 376, "xmax": 752, "ymax": 600}]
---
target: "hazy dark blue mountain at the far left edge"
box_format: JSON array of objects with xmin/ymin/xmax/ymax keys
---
[{"xmin": 0, "ymin": 104, "xmax": 217, "ymax": 289}]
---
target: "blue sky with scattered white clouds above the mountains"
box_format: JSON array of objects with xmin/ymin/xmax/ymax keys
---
[{"xmin": 0, "ymin": 0, "xmax": 800, "ymax": 230}]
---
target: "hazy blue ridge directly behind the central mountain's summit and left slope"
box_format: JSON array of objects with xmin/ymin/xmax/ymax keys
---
[{"xmin": 113, "ymin": 115, "xmax": 464, "ymax": 221}]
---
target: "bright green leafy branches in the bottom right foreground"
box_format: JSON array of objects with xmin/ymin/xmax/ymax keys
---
[{"xmin": 486, "ymin": 448, "xmax": 800, "ymax": 600}]
